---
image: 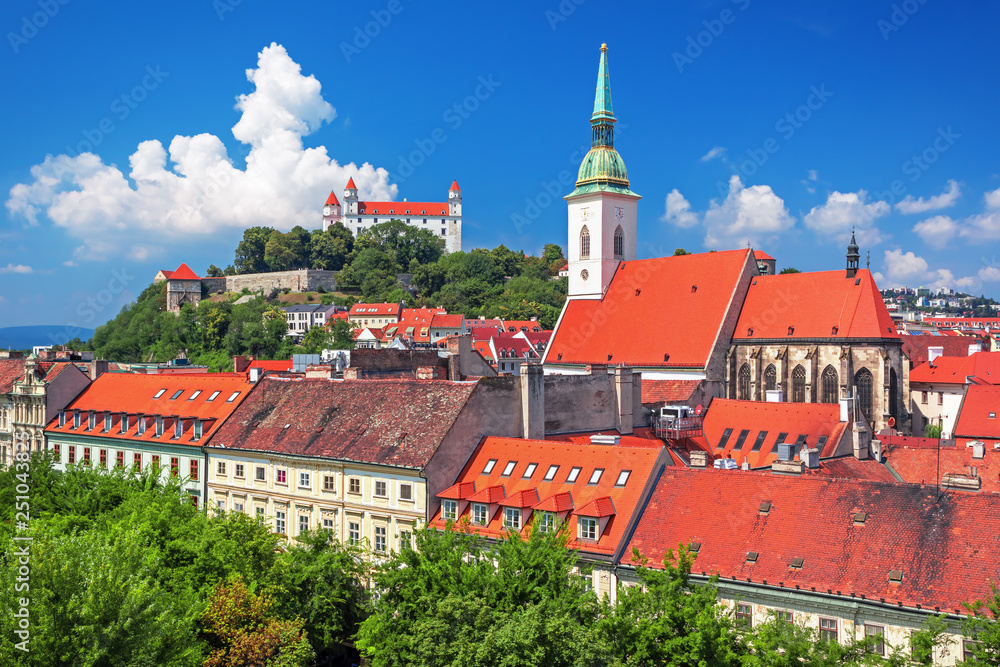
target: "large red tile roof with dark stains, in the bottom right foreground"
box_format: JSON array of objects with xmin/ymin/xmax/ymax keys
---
[{"xmin": 622, "ymin": 468, "xmax": 1000, "ymax": 613}]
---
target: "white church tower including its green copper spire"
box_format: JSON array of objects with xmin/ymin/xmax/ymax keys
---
[{"xmin": 564, "ymin": 44, "xmax": 640, "ymax": 299}]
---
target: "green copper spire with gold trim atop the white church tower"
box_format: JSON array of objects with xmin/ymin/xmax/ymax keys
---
[{"xmin": 568, "ymin": 44, "xmax": 638, "ymax": 197}]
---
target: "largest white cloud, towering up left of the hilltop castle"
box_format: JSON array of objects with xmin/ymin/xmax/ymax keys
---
[{"xmin": 6, "ymin": 44, "xmax": 397, "ymax": 260}]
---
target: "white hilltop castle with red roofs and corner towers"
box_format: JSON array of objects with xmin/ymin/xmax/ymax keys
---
[{"xmin": 323, "ymin": 177, "xmax": 462, "ymax": 252}]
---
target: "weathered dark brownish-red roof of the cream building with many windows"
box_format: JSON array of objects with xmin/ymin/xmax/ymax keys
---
[{"xmin": 209, "ymin": 376, "xmax": 476, "ymax": 468}]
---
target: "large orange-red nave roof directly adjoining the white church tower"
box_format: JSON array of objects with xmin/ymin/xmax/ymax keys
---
[{"xmin": 545, "ymin": 250, "xmax": 756, "ymax": 368}]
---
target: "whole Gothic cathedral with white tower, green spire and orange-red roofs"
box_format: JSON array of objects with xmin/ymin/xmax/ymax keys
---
[{"xmin": 542, "ymin": 44, "xmax": 909, "ymax": 430}]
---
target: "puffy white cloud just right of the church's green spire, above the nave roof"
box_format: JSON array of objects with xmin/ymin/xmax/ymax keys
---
[{"xmin": 704, "ymin": 176, "xmax": 795, "ymax": 248}]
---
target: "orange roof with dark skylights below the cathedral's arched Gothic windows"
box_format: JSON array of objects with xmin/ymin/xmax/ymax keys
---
[{"xmin": 694, "ymin": 398, "xmax": 847, "ymax": 468}]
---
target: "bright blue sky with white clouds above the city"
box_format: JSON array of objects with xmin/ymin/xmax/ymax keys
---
[{"xmin": 0, "ymin": 0, "xmax": 1000, "ymax": 327}]
